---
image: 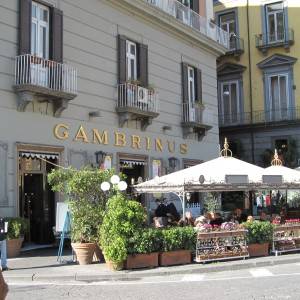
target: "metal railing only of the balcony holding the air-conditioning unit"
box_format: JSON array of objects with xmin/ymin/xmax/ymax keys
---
[{"xmin": 118, "ymin": 83, "xmax": 159, "ymax": 113}]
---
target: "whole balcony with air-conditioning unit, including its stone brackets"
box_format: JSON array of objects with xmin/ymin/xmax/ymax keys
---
[{"xmin": 116, "ymin": 83, "xmax": 159, "ymax": 130}]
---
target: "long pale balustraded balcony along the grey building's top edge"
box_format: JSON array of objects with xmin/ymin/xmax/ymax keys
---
[{"xmin": 144, "ymin": 0, "xmax": 229, "ymax": 49}]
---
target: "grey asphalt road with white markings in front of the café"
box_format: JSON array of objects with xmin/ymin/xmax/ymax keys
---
[{"xmin": 7, "ymin": 263, "xmax": 300, "ymax": 300}]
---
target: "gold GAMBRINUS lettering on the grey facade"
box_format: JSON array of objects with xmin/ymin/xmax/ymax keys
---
[{"xmin": 54, "ymin": 123, "xmax": 188, "ymax": 154}]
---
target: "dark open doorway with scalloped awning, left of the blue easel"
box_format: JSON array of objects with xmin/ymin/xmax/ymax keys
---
[{"xmin": 19, "ymin": 152, "xmax": 57, "ymax": 244}]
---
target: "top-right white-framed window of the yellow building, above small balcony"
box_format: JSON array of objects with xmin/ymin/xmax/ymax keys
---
[{"xmin": 265, "ymin": 2, "xmax": 285, "ymax": 43}]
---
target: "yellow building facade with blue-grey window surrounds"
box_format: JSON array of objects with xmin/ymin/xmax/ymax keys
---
[{"xmin": 214, "ymin": 0, "xmax": 300, "ymax": 167}]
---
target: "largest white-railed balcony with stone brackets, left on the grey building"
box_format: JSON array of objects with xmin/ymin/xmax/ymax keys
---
[{"xmin": 14, "ymin": 54, "xmax": 77, "ymax": 117}]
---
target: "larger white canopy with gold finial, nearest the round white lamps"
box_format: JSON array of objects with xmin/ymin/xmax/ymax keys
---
[{"xmin": 135, "ymin": 156, "xmax": 264, "ymax": 192}]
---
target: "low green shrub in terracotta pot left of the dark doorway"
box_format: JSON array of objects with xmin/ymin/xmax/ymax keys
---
[{"xmin": 5, "ymin": 218, "xmax": 29, "ymax": 258}]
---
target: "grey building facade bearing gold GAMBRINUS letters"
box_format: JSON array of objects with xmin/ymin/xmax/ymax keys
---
[{"xmin": 0, "ymin": 0, "xmax": 228, "ymax": 242}]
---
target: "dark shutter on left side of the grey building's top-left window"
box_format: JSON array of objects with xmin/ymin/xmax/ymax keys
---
[{"xmin": 19, "ymin": 0, "xmax": 32, "ymax": 54}]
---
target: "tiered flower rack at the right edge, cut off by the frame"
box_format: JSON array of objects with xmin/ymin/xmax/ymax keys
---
[{"xmin": 272, "ymin": 223, "xmax": 300, "ymax": 256}]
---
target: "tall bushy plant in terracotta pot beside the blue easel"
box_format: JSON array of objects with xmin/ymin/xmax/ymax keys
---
[{"xmin": 48, "ymin": 168, "xmax": 114, "ymax": 264}]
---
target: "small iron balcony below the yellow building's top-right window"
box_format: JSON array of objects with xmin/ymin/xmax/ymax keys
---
[{"xmin": 255, "ymin": 28, "xmax": 294, "ymax": 53}]
